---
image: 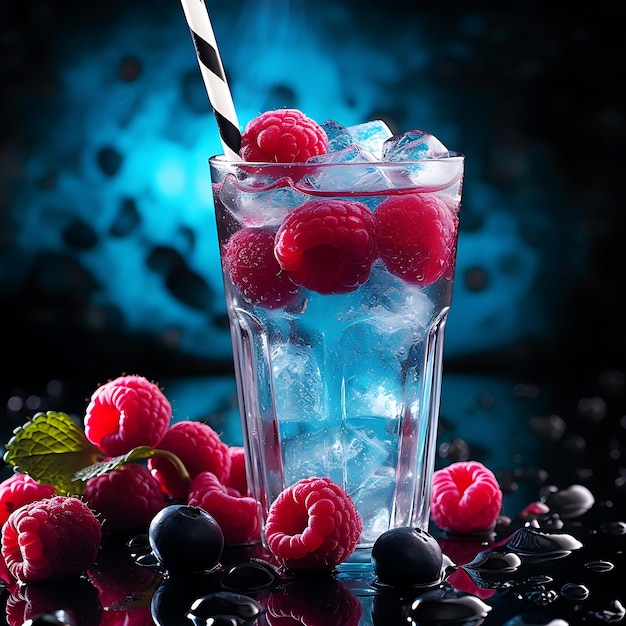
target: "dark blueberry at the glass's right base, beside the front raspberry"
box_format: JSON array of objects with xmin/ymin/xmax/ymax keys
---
[{"xmin": 372, "ymin": 527, "xmax": 443, "ymax": 587}]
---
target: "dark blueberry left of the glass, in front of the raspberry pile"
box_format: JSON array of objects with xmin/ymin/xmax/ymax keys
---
[{"xmin": 148, "ymin": 504, "xmax": 224, "ymax": 573}]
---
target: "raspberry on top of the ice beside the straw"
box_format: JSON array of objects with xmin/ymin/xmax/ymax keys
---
[{"xmin": 239, "ymin": 109, "xmax": 328, "ymax": 163}]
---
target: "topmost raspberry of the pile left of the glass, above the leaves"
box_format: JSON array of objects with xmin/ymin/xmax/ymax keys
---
[{"xmin": 85, "ymin": 376, "xmax": 172, "ymax": 456}]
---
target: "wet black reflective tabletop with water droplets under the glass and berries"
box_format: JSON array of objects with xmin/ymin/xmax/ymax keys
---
[{"xmin": 0, "ymin": 368, "xmax": 626, "ymax": 626}]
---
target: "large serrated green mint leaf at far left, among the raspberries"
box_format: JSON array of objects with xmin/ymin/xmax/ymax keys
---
[{"xmin": 4, "ymin": 411, "xmax": 103, "ymax": 495}]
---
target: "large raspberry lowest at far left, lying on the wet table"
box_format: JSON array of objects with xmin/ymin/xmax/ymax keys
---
[{"xmin": 2, "ymin": 496, "xmax": 102, "ymax": 582}]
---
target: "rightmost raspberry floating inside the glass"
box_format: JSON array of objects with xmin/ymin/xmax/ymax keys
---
[{"xmin": 374, "ymin": 194, "xmax": 458, "ymax": 286}]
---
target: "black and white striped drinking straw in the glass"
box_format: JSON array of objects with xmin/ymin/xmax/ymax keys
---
[{"xmin": 181, "ymin": 0, "xmax": 241, "ymax": 161}]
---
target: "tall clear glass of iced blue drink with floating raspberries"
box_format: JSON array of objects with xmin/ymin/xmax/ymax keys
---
[{"xmin": 210, "ymin": 153, "xmax": 464, "ymax": 547}]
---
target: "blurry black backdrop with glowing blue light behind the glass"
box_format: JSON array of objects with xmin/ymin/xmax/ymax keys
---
[{"xmin": 0, "ymin": 0, "xmax": 626, "ymax": 498}]
